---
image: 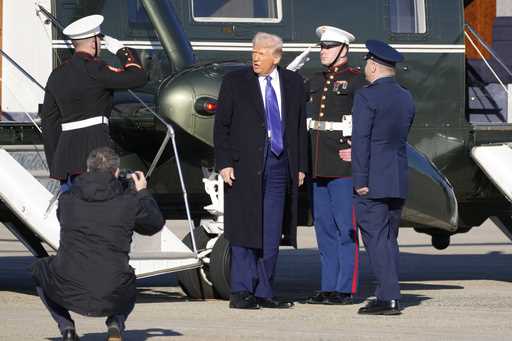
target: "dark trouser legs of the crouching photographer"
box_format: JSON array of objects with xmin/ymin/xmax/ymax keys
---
[{"xmin": 36, "ymin": 287, "xmax": 134, "ymax": 334}]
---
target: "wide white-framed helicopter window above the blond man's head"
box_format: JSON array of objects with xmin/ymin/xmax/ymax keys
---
[{"xmin": 192, "ymin": 0, "xmax": 283, "ymax": 23}]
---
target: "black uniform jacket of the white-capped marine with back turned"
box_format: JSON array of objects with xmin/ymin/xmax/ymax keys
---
[{"xmin": 39, "ymin": 48, "xmax": 148, "ymax": 179}]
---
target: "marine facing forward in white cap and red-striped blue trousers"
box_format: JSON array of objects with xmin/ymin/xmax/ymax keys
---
[{"xmin": 307, "ymin": 26, "xmax": 367, "ymax": 304}]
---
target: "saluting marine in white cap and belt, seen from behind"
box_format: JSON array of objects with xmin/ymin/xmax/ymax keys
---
[{"xmin": 39, "ymin": 15, "xmax": 148, "ymax": 191}]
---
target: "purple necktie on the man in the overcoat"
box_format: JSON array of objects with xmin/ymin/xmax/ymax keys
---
[{"xmin": 265, "ymin": 76, "xmax": 283, "ymax": 156}]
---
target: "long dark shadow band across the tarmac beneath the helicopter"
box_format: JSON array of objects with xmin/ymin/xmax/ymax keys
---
[{"xmin": 0, "ymin": 248, "xmax": 512, "ymax": 303}]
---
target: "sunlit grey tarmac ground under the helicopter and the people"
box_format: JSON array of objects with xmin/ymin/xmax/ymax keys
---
[{"xmin": 0, "ymin": 221, "xmax": 512, "ymax": 341}]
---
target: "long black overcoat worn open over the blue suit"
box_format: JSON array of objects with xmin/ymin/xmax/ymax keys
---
[{"xmin": 214, "ymin": 68, "xmax": 308, "ymax": 248}]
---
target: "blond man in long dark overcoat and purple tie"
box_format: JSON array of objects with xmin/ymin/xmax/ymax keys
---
[{"xmin": 214, "ymin": 33, "xmax": 308, "ymax": 309}]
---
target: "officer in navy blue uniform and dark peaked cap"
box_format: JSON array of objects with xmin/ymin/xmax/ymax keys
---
[{"xmin": 352, "ymin": 40, "xmax": 415, "ymax": 315}]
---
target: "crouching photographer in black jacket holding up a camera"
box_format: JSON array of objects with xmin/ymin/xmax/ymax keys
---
[{"xmin": 32, "ymin": 148, "xmax": 165, "ymax": 341}]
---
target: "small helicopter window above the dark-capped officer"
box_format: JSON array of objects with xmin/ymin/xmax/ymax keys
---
[{"xmin": 389, "ymin": 0, "xmax": 427, "ymax": 33}]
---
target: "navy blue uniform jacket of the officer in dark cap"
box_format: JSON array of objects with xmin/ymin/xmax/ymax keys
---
[{"xmin": 352, "ymin": 77, "xmax": 415, "ymax": 199}]
